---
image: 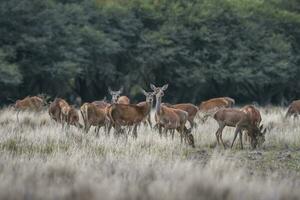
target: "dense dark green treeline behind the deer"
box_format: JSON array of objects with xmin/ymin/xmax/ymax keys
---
[{"xmin": 0, "ymin": 0, "xmax": 300, "ymax": 104}]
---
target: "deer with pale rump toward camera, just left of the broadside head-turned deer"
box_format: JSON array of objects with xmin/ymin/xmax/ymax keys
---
[{"xmin": 80, "ymin": 103, "xmax": 107, "ymax": 136}]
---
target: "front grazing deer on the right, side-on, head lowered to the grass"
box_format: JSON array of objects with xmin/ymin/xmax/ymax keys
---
[{"xmin": 213, "ymin": 108, "xmax": 266, "ymax": 149}]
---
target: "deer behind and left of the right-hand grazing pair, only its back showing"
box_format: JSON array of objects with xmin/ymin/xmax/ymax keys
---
[{"xmin": 199, "ymin": 97, "xmax": 235, "ymax": 123}]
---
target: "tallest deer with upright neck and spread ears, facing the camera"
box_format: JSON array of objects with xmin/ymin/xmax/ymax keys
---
[{"xmin": 150, "ymin": 84, "xmax": 195, "ymax": 147}]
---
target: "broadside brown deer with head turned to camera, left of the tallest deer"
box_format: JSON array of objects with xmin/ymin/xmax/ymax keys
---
[{"xmin": 108, "ymin": 88, "xmax": 152, "ymax": 137}]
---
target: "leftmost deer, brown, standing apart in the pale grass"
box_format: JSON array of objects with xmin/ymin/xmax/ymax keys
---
[{"xmin": 14, "ymin": 96, "xmax": 44, "ymax": 121}]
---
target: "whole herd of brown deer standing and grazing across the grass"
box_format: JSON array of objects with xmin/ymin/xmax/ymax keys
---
[{"xmin": 14, "ymin": 84, "xmax": 300, "ymax": 149}]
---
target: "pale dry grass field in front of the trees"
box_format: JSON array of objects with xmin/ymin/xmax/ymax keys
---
[{"xmin": 0, "ymin": 107, "xmax": 300, "ymax": 200}]
